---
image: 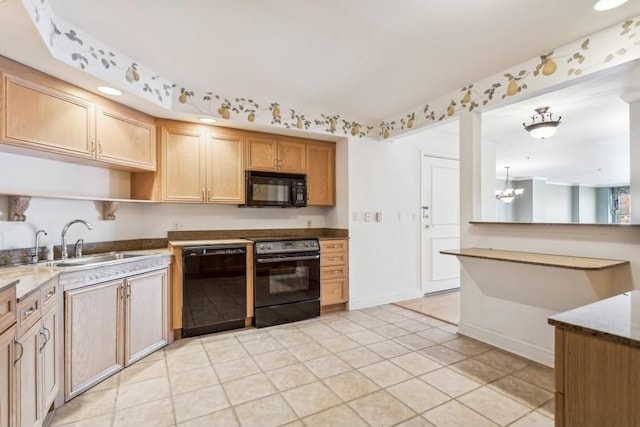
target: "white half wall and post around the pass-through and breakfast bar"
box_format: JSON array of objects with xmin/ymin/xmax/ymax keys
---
[{"xmin": 459, "ymin": 114, "xmax": 640, "ymax": 365}]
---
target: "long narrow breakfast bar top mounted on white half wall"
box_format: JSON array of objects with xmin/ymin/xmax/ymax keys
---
[{"xmin": 440, "ymin": 248, "xmax": 629, "ymax": 270}]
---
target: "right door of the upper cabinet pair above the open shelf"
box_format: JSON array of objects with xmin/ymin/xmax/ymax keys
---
[{"xmin": 96, "ymin": 107, "xmax": 156, "ymax": 170}]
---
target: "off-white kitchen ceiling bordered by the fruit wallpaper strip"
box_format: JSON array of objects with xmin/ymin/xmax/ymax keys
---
[{"xmin": 0, "ymin": 0, "xmax": 640, "ymax": 121}]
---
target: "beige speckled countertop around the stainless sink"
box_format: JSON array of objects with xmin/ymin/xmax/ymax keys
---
[{"xmin": 0, "ymin": 249, "xmax": 171, "ymax": 301}]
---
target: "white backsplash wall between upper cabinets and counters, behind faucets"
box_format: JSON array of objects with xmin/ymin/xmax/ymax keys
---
[{"xmin": 0, "ymin": 148, "xmax": 348, "ymax": 250}]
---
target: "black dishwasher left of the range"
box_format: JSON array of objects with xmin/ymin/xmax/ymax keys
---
[{"xmin": 182, "ymin": 245, "xmax": 247, "ymax": 337}]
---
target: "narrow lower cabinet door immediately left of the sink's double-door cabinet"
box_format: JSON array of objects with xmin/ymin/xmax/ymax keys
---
[{"xmin": 40, "ymin": 308, "xmax": 62, "ymax": 411}]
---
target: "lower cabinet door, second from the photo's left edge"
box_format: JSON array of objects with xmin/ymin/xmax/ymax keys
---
[{"xmin": 15, "ymin": 322, "xmax": 44, "ymax": 426}]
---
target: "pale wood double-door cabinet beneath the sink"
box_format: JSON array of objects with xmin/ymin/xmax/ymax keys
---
[{"xmin": 64, "ymin": 268, "xmax": 169, "ymax": 400}]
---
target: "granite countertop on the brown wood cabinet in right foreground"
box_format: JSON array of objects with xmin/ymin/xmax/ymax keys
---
[{"xmin": 548, "ymin": 290, "xmax": 640, "ymax": 348}]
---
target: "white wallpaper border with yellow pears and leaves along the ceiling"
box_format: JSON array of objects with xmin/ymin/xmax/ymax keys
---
[{"xmin": 22, "ymin": 0, "xmax": 640, "ymax": 139}]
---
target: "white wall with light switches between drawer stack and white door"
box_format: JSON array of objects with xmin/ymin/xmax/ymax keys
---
[{"xmin": 349, "ymin": 123, "xmax": 458, "ymax": 309}]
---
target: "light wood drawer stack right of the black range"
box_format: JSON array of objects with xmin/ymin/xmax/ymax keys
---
[{"xmin": 320, "ymin": 239, "xmax": 349, "ymax": 306}]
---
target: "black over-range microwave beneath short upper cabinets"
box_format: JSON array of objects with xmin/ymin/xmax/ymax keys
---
[{"xmin": 242, "ymin": 171, "xmax": 307, "ymax": 208}]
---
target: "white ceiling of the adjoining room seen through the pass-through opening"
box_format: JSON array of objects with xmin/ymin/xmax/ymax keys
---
[{"xmin": 482, "ymin": 60, "xmax": 640, "ymax": 186}]
